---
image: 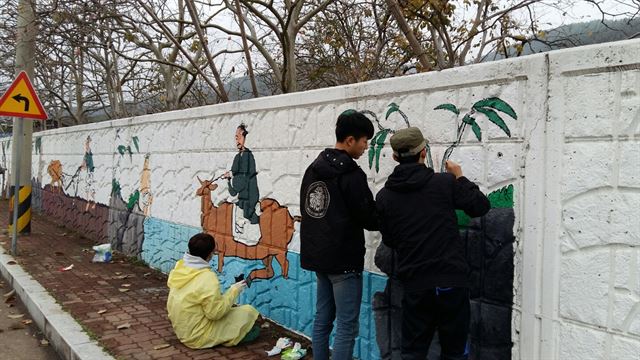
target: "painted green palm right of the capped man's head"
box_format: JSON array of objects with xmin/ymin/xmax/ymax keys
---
[{"xmin": 434, "ymin": 97, "xmax": 518, "ymax": 171}]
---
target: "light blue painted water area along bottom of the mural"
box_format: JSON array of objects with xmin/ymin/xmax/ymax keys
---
[{"xmin": 142, "ymin": 217, "xmax": 387, "ymax": 360}]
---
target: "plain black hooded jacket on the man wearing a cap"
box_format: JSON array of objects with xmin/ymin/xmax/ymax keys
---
[{"xmin": 376, "ymin": 163, "xmax": 490, "ymax": 290}]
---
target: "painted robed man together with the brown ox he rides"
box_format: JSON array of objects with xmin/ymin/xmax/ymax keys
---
[{"xmin": 196, "ymin": 124, "xmax": 299, "ymax": 283}]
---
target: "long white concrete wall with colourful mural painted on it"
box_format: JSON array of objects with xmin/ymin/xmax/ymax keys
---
[{"xmin": 3, "ymin": 40, "xmax": 640, "ymax": 359}]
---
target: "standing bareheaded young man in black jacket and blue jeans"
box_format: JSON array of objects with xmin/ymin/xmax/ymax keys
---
[{"xmin": 300, "ymin": 110, "xmax": 378, "ymax": 360}]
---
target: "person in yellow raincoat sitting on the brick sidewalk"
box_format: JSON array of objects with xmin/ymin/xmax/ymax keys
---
[{"xmin": 167, "ymin": 233, "xmax": 260, "ymax": 349}]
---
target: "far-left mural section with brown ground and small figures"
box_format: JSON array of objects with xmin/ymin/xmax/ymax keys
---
[{"xmin": 35, "ymin": 131, "xmax": 153, "ymax": 256}]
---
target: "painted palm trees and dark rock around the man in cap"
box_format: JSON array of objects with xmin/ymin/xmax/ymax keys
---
[{"xmin": 363, "ymin": 97, "xmax": 517, "ymax": 359}]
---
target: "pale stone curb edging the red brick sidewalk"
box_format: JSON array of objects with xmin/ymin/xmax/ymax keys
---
[{"xmin": 0, "ymin": 246, "xmax": 114, "ymax": 360}]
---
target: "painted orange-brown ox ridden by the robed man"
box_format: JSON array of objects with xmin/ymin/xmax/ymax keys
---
[{"xmin": 196, "ymin": 178, "xmax": 298, "ymax": 280}]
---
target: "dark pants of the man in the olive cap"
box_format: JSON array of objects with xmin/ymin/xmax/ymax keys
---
[{"xmin": 402, "ymin": 288, "xmax": 470, "ymax": 360}]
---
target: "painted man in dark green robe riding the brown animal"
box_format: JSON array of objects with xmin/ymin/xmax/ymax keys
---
[{"xmin": 224, "ymin": 124, "xmax": 260, "ymax": 238}]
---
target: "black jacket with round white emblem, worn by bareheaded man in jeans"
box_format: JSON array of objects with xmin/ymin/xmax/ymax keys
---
[{"xmin": 300, "ymin": 149, "xmax": 378, "ymax": 274}]
